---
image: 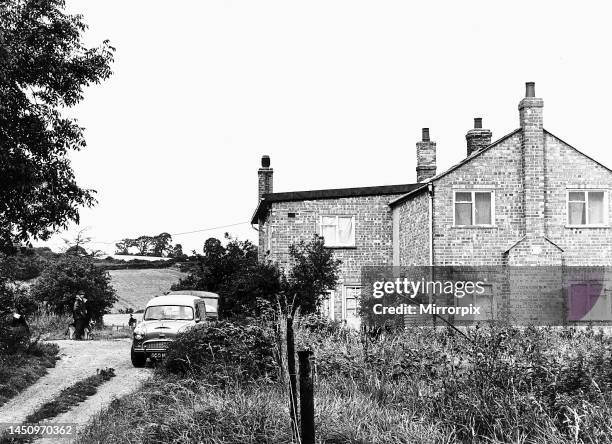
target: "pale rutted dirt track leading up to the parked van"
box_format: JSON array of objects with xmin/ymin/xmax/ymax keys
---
[{"xmin": 0, "ymin": 339, "xmax": 151, "ymax": 442}]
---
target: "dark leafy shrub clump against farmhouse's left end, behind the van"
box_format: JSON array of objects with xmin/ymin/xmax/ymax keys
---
[{"xmin": 172, "ymin": 234, "xmax": 341, "ymax": 318}]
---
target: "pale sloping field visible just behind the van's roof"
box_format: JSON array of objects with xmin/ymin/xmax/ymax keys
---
[{"xmin": 109, "ymin": 268, "xmax": 185, "ymax": 313}]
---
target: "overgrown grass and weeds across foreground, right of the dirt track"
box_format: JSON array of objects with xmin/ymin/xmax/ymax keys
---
[{"xmin": 80, "ymin": 322, "xmax": 612, "ymax": 444}]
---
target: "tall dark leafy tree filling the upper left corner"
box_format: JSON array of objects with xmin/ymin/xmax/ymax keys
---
[{"xmin": 0, "ymin": 0, "xmax": 114, "ymax": 251}]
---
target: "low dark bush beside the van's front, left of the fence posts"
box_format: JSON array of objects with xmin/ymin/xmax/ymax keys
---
[{"xmin": 164, "ymin": 321, "xmax": 279, "ymax": 385}]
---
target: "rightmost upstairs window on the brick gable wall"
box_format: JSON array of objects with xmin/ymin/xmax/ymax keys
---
[{"xmin": 567, "ymin": 190, "xmax": 608, "ymax": 226}]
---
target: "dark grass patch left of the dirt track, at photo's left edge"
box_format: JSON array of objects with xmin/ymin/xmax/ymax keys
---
[{"xmin": 0, "ymin": 342, "xmax": 59, "ymax": 406}]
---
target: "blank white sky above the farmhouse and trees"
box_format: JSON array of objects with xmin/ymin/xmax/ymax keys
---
[{"xmin": 38, "ymin": 0, "xmax": 612, "ymax": 252}]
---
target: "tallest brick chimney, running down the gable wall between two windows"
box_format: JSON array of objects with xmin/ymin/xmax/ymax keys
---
[{"xmin": 519, "ymin": 82, "xmax": 546, "ymax": 236}]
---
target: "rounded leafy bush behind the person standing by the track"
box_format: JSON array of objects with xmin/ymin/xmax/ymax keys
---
[{"xmin": 32, "ymin": 255, "xmax": 117, "ymax": 321}]
